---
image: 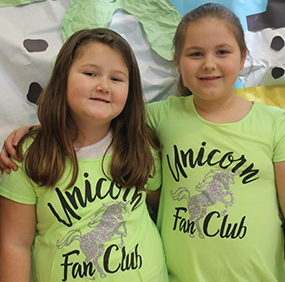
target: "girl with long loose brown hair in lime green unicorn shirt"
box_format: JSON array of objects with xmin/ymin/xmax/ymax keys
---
[{"xmin": 0, "ymin": 29, "xmax": 168, "ymax": 282}]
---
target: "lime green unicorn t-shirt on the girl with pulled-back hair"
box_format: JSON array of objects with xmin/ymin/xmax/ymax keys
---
[{"xmin": 147, "ymin": 96, "xmax": 285, "ymax": 282}]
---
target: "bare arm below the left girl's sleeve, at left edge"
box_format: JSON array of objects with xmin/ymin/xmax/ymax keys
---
[{"xmin": 0, "ymin": 196, "xmax": 36, "ymax": 282}]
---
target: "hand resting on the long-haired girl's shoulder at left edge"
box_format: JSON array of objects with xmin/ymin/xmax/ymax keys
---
[{"xmin": 0, "ymin": 125, "xmax": 31, "ymax": 173}]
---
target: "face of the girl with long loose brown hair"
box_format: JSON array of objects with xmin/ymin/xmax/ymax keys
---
[{"xmin": 67, "ymin": 42, "xmax": 129, "ymax": 134}]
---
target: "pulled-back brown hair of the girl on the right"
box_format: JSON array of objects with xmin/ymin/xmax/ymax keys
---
[{"xmin": 172, "ymin": 3, "xmax": 248, "ymax": 96}]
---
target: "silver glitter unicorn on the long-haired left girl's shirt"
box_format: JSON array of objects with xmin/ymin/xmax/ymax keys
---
[{"xmin": 56, "ymin": 201, "xmax": 128, "ymax": 278}]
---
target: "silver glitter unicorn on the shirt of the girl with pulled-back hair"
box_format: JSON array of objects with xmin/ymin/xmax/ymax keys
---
[{"xmin": 170, "ymin": 169, "xmax": 239, "ymax": 238}]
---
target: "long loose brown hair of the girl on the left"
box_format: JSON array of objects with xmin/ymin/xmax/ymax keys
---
[{"xmin": 17, "ymin": 28, "xmax": 159, "ymax": 190}]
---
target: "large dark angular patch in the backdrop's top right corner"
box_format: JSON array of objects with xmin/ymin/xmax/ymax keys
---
[{"xmin": 246, "ymin": 0, "xmax": 285, "ymax": 31}]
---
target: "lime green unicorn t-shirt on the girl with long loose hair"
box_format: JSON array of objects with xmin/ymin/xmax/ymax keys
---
[{"xmin": 0, "ymin": 150, "xmax": 168, "ymax": 282}]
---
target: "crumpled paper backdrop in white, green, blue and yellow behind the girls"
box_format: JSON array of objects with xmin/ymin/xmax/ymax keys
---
[{"xmin": 0, "ymin": 0, "xmax": 285, "ymax": 150}]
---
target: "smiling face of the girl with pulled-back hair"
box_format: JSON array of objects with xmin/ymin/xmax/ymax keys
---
[{"xmin": 174, "ymin": 18, "xmax": 245, "ymax": 101}]
